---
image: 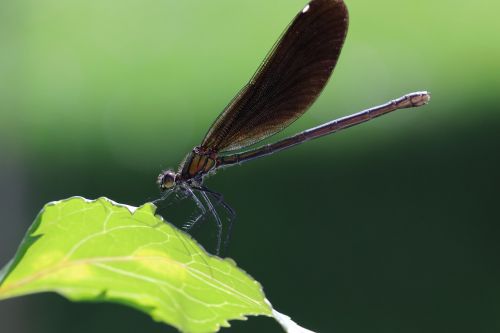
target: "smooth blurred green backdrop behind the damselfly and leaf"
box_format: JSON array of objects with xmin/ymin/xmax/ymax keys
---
[{"xmin": 0, "ymin": 0, "xmax": 500, "ymax": 333}]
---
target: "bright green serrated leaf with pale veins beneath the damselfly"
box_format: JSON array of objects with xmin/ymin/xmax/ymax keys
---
[{"xmin": 0, "ymin": 197, "xmax": 273, "ymax": 332}]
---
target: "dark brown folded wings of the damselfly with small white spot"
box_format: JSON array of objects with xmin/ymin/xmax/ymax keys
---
[{"xmin": 201, "ymin": 0, "xmax": 348, "ymax": 151}]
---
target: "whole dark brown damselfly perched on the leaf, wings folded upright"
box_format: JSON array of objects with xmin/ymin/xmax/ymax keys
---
[{"xmin": 157, "ymin": 0, "xmax": 430, "ymax": 255}]
